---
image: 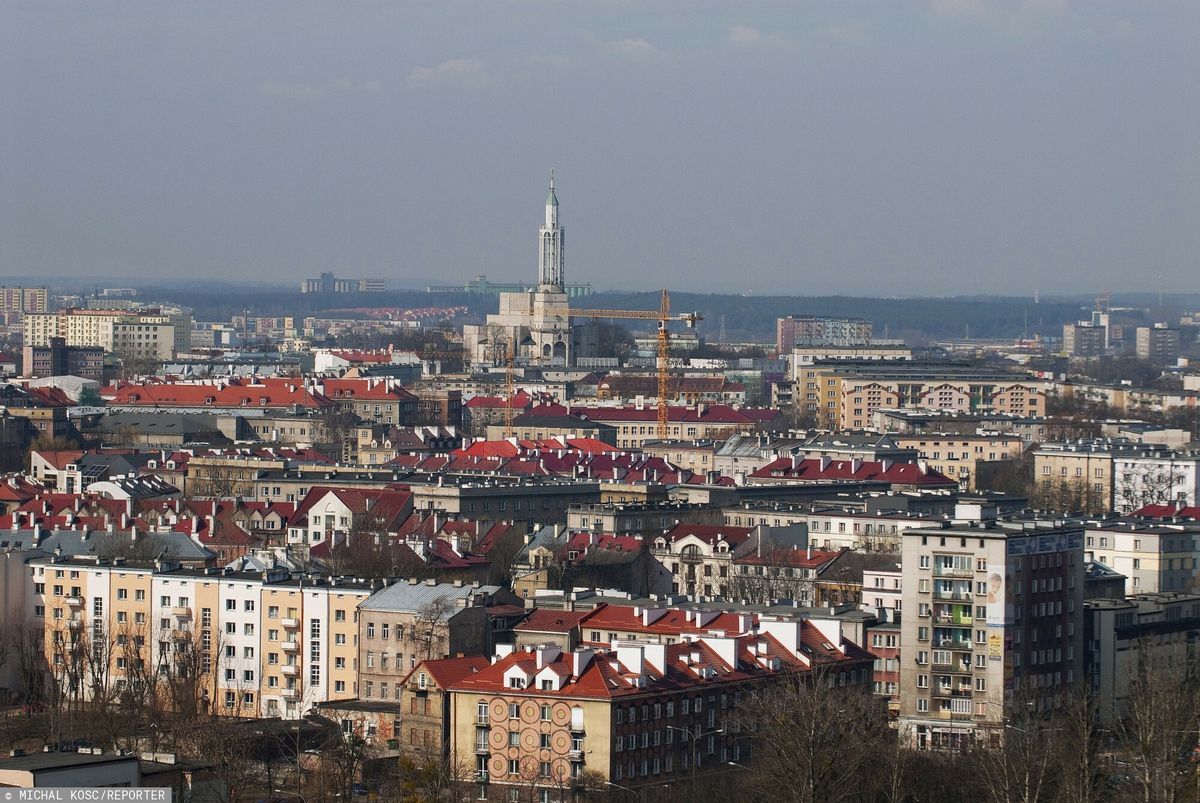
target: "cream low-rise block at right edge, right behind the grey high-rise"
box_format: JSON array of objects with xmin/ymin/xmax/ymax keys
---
[{"xmin": 1085, "ymin": 521, "xmax": 1200, "ymax": 597}]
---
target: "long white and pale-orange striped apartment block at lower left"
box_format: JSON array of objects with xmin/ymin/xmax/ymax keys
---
[{"xmin": 29, "ymin": 556, "xmax": 371, "ymax": 718}]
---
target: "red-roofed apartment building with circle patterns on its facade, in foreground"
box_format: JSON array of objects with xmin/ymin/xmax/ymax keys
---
[{"xmin": 449, "ymin": 617, "xmax": 872, "ymax": 801}]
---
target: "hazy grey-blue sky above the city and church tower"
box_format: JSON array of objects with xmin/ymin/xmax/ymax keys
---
[{"xmin": 0, "ymin": 0, "xmax": 1200, "ymax": 295}]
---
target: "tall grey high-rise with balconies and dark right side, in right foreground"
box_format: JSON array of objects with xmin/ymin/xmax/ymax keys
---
[{"xmin": 900, "ymin": 505, "xmax": 1085, "ymax": 749}]
